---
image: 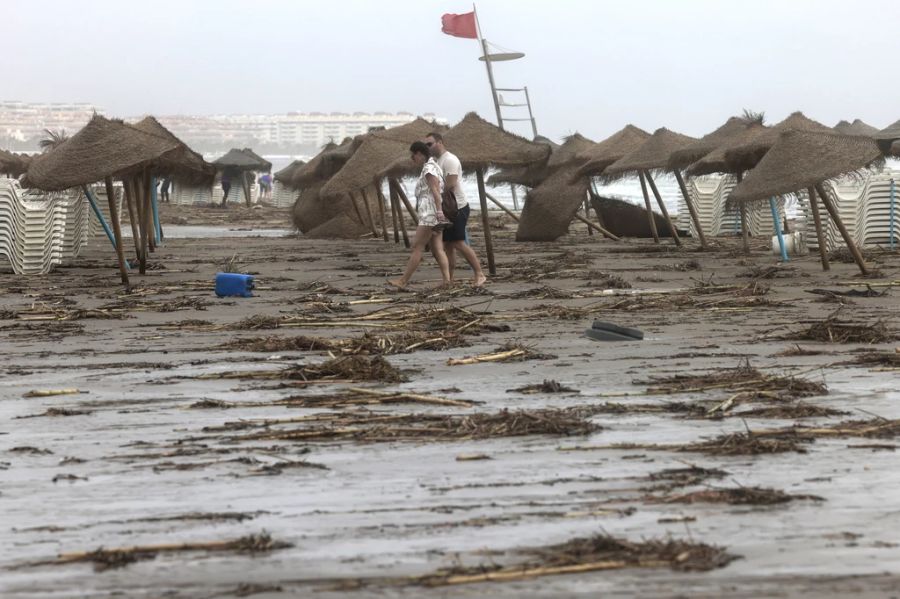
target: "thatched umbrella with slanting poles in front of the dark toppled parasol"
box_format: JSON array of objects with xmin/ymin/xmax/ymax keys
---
[{"xmin": 603, "ymin": 127, "xmax": 706, "ymax": 246}]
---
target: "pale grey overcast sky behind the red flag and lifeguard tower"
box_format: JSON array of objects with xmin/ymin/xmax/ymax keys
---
[{"xmin": 7, "ymin": 0, "xmax": 900, "ymax": 139}]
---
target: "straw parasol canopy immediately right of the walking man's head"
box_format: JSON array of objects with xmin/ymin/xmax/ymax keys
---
[{"xmin": 443, "ymin": 112, "xmax": 550, "ymax": 170}]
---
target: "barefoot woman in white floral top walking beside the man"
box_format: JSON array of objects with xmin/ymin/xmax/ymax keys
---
[{"xmin": 388, "ymin": 141, "xmax": 450, "ymax": 289}]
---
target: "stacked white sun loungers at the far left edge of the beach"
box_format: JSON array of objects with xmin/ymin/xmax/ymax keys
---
[{"xmin": 0, "ymin": 179, "xmax": 89, "ymax": 274}]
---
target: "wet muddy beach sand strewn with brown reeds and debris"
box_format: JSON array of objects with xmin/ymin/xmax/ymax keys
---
[{"xmin": 0, "ymin": 213, "xmax": 900, "ymax": 598}]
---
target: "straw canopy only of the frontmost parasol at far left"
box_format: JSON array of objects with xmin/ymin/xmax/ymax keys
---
[{"xmin": 26, "ymin": 114, "xmax": 177, "ymax": 191}]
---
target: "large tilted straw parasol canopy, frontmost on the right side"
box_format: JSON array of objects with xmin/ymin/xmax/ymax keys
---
[{"xmin": 728, "ymin": 130, "xmax": 881, "ymax": 203}]
